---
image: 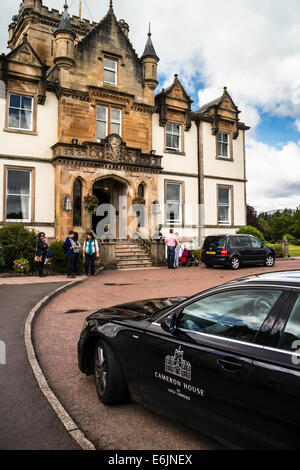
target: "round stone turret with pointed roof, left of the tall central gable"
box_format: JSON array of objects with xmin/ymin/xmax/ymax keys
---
[{"xmin": 54, "ymin": 0, "xmax": 76, "ymax": 69}]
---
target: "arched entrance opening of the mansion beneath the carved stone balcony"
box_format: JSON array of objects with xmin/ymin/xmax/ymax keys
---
[{"xmin": 92, "ymin": 176, "xmax": 130, "ymax": 239}]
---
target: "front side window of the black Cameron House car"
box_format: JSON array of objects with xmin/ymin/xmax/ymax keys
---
[{"xmin": 178, "ymin": 289, "xmax": 281, "ymax": 342}]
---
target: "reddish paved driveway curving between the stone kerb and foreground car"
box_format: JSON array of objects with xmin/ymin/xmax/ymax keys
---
[{"xmin": 34, "ymin": 260, "xmax": 300, "ymax": 450}]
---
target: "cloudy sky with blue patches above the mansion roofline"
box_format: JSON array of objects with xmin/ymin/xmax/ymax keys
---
[{"xmin": 0, "ymin": 0, "xmax": 300, "ymax": 211}]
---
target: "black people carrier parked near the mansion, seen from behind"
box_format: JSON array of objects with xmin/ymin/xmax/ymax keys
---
[{"xmin": 201, "ymin": 235, "xmax": 275, "ymax": 269}]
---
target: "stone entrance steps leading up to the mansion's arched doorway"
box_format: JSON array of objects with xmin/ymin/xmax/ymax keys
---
[{"xmin": 116, "ymin": 241, "xmax": 152, "ymax": 270}]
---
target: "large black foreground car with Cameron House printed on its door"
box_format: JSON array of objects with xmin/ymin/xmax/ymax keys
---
[{"xmin": 78, "ymin": 271, "xmax": 300, "ymax": 449}]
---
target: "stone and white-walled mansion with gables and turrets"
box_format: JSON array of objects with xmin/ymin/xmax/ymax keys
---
[{"xmin": 0, "ymin": 0, "xmax": 249, "ymax": 250}]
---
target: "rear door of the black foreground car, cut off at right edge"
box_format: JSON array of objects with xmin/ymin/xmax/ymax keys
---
[{"xmin": 244, "ymin": 293, "xmax": 300, "ymax": 449}]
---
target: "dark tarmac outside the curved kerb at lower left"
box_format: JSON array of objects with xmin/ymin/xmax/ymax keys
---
[{"xmin": 0, "ymin": 283, "xmax": 80, "ymax": 450}]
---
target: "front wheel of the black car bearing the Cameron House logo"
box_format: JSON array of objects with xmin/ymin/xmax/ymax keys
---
[{"xmin": 94, "ymin": 340, "xmax": 129, "ymax": 405}]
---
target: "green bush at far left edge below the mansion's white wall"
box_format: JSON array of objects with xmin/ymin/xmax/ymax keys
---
[{"xmin": 0, "ymin": 223, "xmax": 37, "ymax": 268}]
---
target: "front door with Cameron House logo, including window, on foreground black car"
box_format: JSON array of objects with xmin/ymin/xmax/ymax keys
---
[{"xmin": 139, "ymin": 288, "xmax": 282, "ymax": 447}]
